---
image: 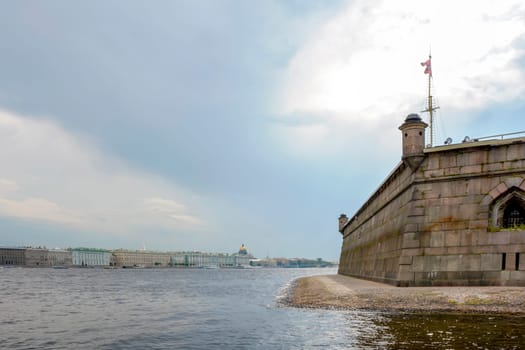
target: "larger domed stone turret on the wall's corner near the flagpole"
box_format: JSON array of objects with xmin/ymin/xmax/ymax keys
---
[{"xmin": 399, "ymin": 113, "xmax": 428, "ymax": 171}]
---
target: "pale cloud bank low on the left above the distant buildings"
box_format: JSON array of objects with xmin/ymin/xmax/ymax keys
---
[{"xmin": 0, "ymin": 112, "xmax": 205, "ymax": 234}]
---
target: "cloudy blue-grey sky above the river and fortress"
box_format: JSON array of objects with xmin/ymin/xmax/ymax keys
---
[{"xmin": 0, "ymin": 0, "xmax": 525, "ymax": 261}]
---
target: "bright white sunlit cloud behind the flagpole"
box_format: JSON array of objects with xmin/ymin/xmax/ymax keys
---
[{"xmin": 278, "ymin": 0, "xmax": 525, "ymax": 154}]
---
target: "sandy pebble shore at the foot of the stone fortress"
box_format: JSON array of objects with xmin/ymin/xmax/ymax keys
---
[{"xmin": 289, "ymin": 275, "xmax": 525, "ymax": 315}]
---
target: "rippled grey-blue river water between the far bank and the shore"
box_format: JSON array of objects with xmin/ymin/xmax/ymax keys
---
[{"xmin": 0, "ymin": 268, "xmax": 525, "ymax": 349}]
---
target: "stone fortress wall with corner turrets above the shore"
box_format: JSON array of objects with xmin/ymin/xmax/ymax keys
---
[{"xmin": 339, "ymin": 115, "xmax": 525, "ymax": 286}]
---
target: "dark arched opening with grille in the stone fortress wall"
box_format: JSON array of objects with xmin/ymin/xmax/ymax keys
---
[{"xmin": 491, "ymin": 187, "xmax": 525, "ymax": 229}]
